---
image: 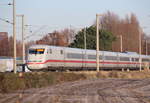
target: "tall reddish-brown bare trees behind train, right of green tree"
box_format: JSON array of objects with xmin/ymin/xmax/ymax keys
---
[{"xmin": 101, "ymin": 11, "xmax": 143, "ymax": 52}]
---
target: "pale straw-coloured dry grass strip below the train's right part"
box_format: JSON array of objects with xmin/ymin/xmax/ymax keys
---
[{"xmin": 71, "ymin": 70, "xmax": 150, "ymax": 79}]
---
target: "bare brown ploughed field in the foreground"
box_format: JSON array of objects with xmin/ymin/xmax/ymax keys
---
[{"xmin": 0, "ymin": 79, "xmax": 150, "ymax": 103}]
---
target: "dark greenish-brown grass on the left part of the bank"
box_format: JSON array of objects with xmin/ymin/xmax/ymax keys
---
[{"xmin": 0, "ymin": 72, "xmax": 86, "ymax": 93}]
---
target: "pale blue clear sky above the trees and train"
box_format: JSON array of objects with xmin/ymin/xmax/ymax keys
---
[{"xmin": 0, "ymin": 0, "xmax": 150, "ymax": 40}]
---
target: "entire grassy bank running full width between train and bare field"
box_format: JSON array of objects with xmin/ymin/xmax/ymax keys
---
[{"xmin": 0, "ymin": 71, "xmax": 150, "ymax": 93}]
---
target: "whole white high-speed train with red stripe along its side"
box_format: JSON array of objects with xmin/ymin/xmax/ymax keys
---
[{"xmin": 27, "ymin": 45, "xmax": 150, "ymax": 71}]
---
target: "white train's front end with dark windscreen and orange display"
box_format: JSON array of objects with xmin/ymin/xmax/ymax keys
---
[{"xmin": 27, "ymin": 48, "xmax": 46, "ymax": 71}]
